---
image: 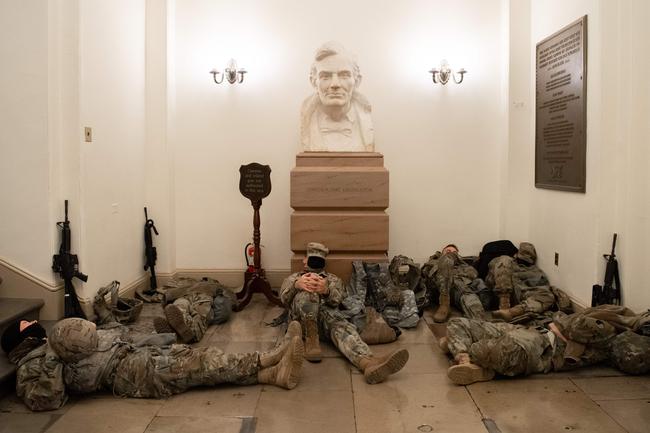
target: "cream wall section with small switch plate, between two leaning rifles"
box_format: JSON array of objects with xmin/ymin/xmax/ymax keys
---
[{"xmin": 79, "ymin": 0, "xmax": 145, "ymax": 297}]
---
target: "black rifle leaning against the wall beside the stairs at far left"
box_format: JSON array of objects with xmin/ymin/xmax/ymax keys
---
[{"xmin": 52, "ymin": 200, "xmax": 88, "ymax": 319}]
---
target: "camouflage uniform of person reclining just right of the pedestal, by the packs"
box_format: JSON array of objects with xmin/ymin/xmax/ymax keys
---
[{"xmin": 422, "ymin": 251, "xmax": 490, "ymax": 319}]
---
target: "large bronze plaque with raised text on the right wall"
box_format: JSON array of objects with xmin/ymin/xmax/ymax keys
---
[{"xmin": 535, "ymin": 15, "xmax": 587, "ymax": 192}]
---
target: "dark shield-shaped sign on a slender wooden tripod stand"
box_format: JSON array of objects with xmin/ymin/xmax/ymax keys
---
[{"xmin": 234, "ymin": 162, "xmax": 282, "ymax": 311}]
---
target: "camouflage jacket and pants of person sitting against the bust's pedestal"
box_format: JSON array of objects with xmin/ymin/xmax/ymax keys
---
[{"xmin": 280, "ymin": 271, "xmax": 372, "ymax": 369}]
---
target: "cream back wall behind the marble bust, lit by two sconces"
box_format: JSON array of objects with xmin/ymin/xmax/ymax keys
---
[{"xmin": 171, "ymin": 0, "xmax": 506, "ymax": 269}]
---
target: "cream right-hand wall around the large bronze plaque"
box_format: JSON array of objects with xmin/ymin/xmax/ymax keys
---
[{"xmin": 503, "ymin": 0, "xmax": 650, "ymax": 310}]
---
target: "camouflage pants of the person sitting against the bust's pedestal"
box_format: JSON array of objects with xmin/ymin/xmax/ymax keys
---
[{"xmin": 291, "ymin": 290, "xmax": 372, "ymax": 368}]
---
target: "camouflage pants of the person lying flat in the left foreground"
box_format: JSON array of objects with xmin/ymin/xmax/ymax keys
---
[{"xmin": 112, "ymin": 344, "xmax": 260, "ymax": 398}]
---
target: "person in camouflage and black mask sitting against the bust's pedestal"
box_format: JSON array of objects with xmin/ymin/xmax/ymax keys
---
[{"xmin": 280, "ymin": 242, "xmax": 409, "ymax": 384}]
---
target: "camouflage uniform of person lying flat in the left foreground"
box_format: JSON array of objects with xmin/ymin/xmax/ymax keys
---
[{"xmin": 16, "ymin": 325, "xmax": 260, "ymax": 411}]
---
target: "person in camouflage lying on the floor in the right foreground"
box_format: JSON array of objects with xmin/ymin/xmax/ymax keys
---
[{"xmin": 440, "ymin": 305, "xmax": 650, "ymax": 385}]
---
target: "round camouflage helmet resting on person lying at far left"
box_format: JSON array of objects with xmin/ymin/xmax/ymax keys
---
[{"xmin": 48, "ymin": 317, "xmax": 99, "ymax": 362}]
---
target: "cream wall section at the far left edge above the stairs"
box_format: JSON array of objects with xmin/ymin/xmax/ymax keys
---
[{"xmin": 0, "ymin": 1, "xmax": 53, "ymax": 282}]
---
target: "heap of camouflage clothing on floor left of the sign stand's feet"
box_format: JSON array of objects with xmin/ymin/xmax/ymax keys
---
[{"xmin": 163, "ymin": 278, "xmax": 233, "ymax": 343}]
